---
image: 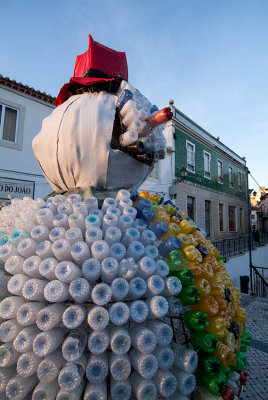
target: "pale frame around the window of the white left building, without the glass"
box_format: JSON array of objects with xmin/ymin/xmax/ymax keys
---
[{"xmin": 0, "ymin": 98, "xmax": 25, "ymax": 150}]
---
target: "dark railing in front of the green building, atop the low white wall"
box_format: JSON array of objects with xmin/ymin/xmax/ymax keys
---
[{"xmin": 212, "ymin": 232, "xmax": 268, "ymax": 259}]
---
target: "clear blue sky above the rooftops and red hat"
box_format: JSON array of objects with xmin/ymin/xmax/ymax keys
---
[{"xmin": 0, "ymin": 0, "xmax": 268, "ymax": 189}]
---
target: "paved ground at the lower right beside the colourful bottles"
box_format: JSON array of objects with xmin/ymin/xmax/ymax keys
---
[{"xmin": 241, "ymin": 295, "xmax": 268, "ymax": 400}]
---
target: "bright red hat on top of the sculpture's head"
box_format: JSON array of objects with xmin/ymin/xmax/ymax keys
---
[{"xmin": 55, "ymin": 35, "xmax": 128, "ymax": 106}]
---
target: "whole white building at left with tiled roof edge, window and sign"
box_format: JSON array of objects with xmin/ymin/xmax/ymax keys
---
[{"xmin": 0, "ymin": 75, "xmax": 55, "ymax": 202}]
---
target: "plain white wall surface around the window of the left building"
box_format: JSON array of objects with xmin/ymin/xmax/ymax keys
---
[{"xmin": 0, "ymin": 87, "xmax": 54, "ymax": 198}]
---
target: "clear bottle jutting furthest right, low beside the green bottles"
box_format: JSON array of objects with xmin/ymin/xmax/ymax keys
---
[{"xmin": 172, "ymin": 343, "xmax": 198, "ymax": 374}]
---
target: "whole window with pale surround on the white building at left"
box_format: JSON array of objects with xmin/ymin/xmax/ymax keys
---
[{"xmin": 0, "ymin": 99, "xmax": 24, "ymax": 150}]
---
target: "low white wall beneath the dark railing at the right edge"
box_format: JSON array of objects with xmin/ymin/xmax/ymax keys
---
[{"xmin": 226, "ymin": 246, "xmax": 268, "ymax": 288}]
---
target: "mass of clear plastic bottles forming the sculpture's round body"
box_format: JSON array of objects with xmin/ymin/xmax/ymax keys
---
[{"xmin": 0, "ymin": 190, "xmax": 201, "ymax": 400}]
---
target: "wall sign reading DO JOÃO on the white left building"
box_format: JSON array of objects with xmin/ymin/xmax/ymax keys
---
[{"xmin": 0, "ymin": 176, "xmax": 35, "ymax": 200}]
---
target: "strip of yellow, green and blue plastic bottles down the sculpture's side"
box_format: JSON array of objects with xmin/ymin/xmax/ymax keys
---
[{"xmin": 136, "ymin": 191, "xmax": 250, "ymax": 400}]
